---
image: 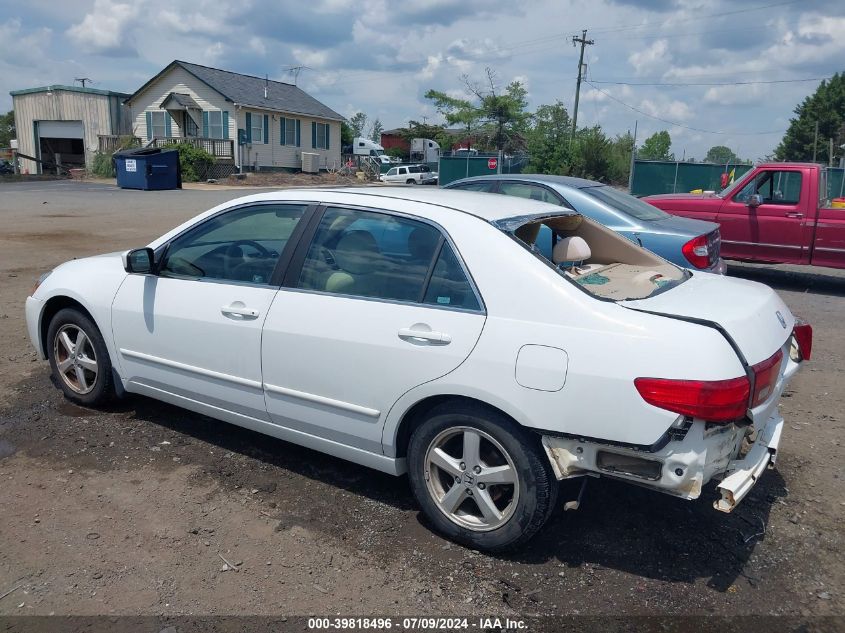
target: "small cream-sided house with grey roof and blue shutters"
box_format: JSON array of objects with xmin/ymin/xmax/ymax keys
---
[{"xmin": 126, "ymin": 60, "xmax": 343, "ymax": 175}]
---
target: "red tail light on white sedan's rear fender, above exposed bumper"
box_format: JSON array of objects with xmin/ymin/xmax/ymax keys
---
[{"xmin": 634, "ymin": 376, "xmax": 751, "ymax": 422}]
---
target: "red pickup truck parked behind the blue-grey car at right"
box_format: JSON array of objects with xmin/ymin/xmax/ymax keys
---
[{"xmin": 643, "ymin": 163, "xmax": 845, "ymax": 268}]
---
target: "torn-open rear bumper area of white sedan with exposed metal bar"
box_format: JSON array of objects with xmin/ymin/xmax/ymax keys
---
[{"xmin": 543, "ymin": 410, "xmax": 783, "ymax": 512}]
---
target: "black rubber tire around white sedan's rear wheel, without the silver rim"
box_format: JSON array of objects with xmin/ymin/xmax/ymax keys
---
[{"xmin": 408, "ymin": 402, "xmax": 558, "ymax": 552}]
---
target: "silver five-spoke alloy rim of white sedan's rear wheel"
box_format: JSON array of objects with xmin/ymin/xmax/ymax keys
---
[{"xmin": 425, "ymin": 426, "xmax": 519, "ymax": 532}]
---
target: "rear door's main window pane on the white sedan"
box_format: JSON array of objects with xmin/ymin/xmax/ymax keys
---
[{"xmin": 297, "ymin": 208, "xmax": 442, "ymax": 301}]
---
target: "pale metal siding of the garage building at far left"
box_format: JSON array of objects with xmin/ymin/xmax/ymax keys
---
[{"xmin": 12, "ymin": 89, "xmax": 123, "ymax": 174}]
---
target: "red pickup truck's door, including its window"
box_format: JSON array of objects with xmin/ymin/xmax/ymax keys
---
[{"xmin": 717, "ymin": 169, "xmax": 809, "ymax": 263}]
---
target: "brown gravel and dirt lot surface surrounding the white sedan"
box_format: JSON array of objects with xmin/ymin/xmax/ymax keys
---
[{"xmin": 0, "ymin": 181, "xmax": 845, "ymax": 622}]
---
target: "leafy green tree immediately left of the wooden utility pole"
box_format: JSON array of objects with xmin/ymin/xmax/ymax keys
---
[{"xmin": 526, "ymin": 101, "xmax": 572, "ymax": 174}]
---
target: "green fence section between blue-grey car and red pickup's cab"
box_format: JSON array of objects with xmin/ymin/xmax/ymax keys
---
[{"xmin": 630, "ymin": 159, "xmax": 752, "ymax": 196}]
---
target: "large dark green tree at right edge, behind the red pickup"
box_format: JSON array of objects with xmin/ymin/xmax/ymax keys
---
[{"xmin": 775, "ymin": 73, "xmax": 845, "ymax": 162}]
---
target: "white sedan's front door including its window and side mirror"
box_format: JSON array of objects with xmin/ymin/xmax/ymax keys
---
[{"xmin": 112, "ymin": 203, "xmax": 307, "ymax": 420}]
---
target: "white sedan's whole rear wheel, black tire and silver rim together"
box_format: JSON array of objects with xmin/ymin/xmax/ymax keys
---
[{"xmin": 408, "ymin": 403, "xmax": 558, "ymax": 552}]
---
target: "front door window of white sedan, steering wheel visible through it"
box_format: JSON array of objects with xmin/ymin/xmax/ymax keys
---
[{"xmin": 159, "ymin": 204, "xmax": 306, "ymax": 284}]
